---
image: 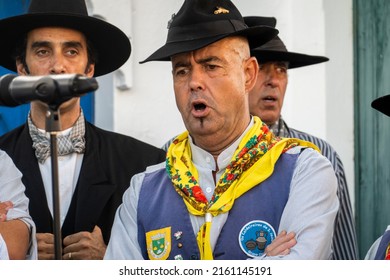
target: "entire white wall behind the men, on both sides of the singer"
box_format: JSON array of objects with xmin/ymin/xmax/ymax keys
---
[{"xmin": 88, "ymin": 0, "xmax": 354, "ymax": 208}]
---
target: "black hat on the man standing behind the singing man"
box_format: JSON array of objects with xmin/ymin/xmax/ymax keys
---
[{"xmin": 244, "ymin": 16, "xmax": 329, "ymax": 69}]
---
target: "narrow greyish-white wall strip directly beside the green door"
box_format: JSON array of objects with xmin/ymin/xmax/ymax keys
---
[{"xmin": 323, "ymin": 0, "xmax": 355, "ymax": 208}]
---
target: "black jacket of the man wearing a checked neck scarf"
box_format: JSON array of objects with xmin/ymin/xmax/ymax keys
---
[{"xmin": 0, "ymin": 122, "xmax": 165, "ymax": 244}]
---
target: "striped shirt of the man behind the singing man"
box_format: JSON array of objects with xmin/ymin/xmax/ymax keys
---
[{"xmin": 270, "ymin": 118, "xmax": 358, "ymax": 260}]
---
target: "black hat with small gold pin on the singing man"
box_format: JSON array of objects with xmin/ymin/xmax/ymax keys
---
[{"xmin": 140, "ymin": 0, "xmax": 278, "ymax": 63}]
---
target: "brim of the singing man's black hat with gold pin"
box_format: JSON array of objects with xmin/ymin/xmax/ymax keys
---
[{"xmin": 140, "ymin": 26, "xmax": 278, "ymax": 64}]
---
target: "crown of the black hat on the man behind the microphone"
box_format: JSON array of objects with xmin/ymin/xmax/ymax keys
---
[{"xmin": 28, "ymin": 0, "xmax": 88, "ymax": 16}]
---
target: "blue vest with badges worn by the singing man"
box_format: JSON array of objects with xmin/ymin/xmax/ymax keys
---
[{"xmin": 137, "ymin": 154, "xmax": 298, "ymax": 260}]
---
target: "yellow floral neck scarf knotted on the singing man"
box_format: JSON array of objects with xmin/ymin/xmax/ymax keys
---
[{"xmin": 166, "ymin": 117, "xmax": 319, "ymax": 260}]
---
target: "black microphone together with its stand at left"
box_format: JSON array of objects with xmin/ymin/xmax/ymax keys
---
[{"xmin": 0, "ymin": 74, "xmax": 98, "ymax": 260}]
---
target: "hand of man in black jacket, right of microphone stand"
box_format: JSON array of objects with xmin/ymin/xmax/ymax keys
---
[{"xmin": 62, "ymin": 226, "xmax": 107, "ymax": 260}]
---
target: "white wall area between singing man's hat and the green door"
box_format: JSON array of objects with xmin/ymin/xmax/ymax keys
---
[{"xmin": 235, "ymin": 0, "xmax": 354, "ymax": 204}]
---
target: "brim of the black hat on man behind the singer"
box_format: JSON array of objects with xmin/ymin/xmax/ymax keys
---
[{"xmin": 251, "ymin": 49, "xmax": 329, "ymax": 69}]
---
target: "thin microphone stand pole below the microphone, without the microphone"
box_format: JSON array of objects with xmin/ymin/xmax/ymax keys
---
[{"xmin": 46, "ymin": 104, "xmax": 62, "ymax": 260}]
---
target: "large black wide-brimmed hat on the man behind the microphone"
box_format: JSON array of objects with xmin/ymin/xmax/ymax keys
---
[{"xmin": 0, "ymin": 0, "xmax": 131, "ymax": 76}]
